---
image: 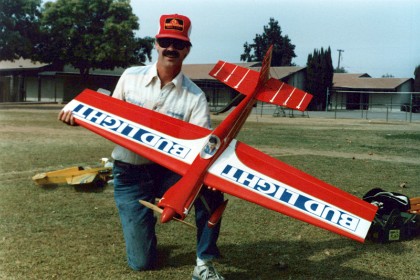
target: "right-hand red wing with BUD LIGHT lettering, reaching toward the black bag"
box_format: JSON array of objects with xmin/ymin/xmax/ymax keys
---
[{"xmin": 204, "ymin": 140, "xmax": 377, "ymax": 242}]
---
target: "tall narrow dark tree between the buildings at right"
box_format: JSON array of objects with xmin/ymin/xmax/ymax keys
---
[{"xmin": 306, "ymin": 47, "xmax": 334, "ymax": 110}]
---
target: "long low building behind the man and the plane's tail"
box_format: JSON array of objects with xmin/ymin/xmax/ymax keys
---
[{"xmin": 0, "ymin": 61, "xmax": 306, "ymax": 111}]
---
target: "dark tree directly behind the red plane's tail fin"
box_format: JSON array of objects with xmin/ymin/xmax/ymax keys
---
[{"xmin": 241, "ymin": 18, "xmax": 296, "ymax": 66}]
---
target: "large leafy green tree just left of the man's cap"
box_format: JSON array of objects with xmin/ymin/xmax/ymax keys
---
[{"xmin": 35, "ymin": 0, "xmax": 153, "ymax": 77}]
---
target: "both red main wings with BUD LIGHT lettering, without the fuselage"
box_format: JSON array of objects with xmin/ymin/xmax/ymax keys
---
[{"xmin": 65, "ymin": 90, "xmax": 377, "ymax": 241}]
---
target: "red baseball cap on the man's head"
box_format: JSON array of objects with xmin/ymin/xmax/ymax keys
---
[{"xmin": 156, "ymin": 14, "xmax": 191, "ymax": 42}]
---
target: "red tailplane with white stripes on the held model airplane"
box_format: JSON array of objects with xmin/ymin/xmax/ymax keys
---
[{"xmin": 209, "ymin": 61, "xmax": 312, "ymax": 111}]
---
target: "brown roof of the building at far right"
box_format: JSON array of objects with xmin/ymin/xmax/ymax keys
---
[{"xmin": 333, "ymin": 73, "xmax": 412, "ymax": 91}]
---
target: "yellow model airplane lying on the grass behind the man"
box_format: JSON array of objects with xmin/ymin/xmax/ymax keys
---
[{"xmin": 32, "ymin": 160, "xmax": 112, "ymax": 187}]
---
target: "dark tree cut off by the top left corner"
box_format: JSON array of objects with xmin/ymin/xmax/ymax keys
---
[{"xmin": 0, "ymin": 0, "xmax": 41, "ymax": 61}]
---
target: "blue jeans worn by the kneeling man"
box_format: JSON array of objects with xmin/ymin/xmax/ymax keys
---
[{"xmin": 113, "ymin": 161, "xmax": 223, "ymax": 270}]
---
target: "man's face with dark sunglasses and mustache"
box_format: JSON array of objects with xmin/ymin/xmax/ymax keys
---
[{"xmin": 155, "ymin": 38, "xmax": 190, "ymax": 66}]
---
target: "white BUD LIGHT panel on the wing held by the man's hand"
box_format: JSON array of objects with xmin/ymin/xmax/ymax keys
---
[{"xmin": 73, "ymin": 103, "xmax": 191, "ymax": 159}]
